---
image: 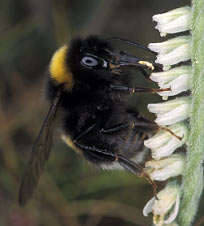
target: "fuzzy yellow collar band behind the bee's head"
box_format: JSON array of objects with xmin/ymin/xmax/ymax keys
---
[{"xmin": 49, "ymin": 45, "xmax": 73, "ymax": 91}]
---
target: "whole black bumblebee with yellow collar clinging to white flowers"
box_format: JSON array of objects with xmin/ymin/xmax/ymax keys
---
[{"xmin": 19, "ymin": 36, "xmax": 169, "ymax": 205}]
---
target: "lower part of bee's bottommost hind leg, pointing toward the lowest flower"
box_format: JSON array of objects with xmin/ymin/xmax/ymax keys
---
[{"xmin": 117, "ymin": 155, "xmax": 157, "ymax": 199}]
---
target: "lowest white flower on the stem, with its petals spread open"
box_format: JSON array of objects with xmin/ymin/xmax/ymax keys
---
[{"xmin": 143, "ymin": 183, "xmax": 180, "ymax": 226}]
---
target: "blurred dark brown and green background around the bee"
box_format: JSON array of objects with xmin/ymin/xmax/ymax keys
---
[{"xmin": 0, "ymin": 0, "xmax": 204, "ymax": 226}]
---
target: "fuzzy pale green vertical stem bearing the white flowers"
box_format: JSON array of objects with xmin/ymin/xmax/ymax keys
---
[{"xmin": 178, "ymin": 0, "xmax": 204, "ymax": 226}]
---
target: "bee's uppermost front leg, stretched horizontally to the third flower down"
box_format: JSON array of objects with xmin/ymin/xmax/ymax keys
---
[{"xmin": 110, "ymin": 84, "xmax": 171, "ymax": 94}]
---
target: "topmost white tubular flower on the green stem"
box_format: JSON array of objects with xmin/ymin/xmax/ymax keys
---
[{"xmin": 153, "ymin": 6, "xmax": 191, "ymax": 36}]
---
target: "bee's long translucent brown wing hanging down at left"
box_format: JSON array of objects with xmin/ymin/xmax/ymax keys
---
[{"xmin": 18, "ymin": 95, "xmax": 60, "ymax": 206}]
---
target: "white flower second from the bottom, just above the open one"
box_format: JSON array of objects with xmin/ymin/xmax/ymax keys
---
[{"xmin": 144, "ymin": 154, "xmax": 185, "ymax": 181}]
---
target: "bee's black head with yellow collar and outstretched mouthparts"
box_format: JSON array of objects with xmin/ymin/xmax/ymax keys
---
[{"xmin": 49, "ymin": 36, "xmax": 159, "ymax": 90}]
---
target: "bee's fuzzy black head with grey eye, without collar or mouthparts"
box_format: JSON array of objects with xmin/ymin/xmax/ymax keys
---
[{"xmin": 67, "ymin": 36, "xmax": 116, "ymax": 81}]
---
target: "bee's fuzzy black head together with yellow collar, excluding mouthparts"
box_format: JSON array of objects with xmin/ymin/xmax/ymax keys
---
[{"xmin": 49, "ymin": 36, "xmax": 118, "ymax": 90}]
